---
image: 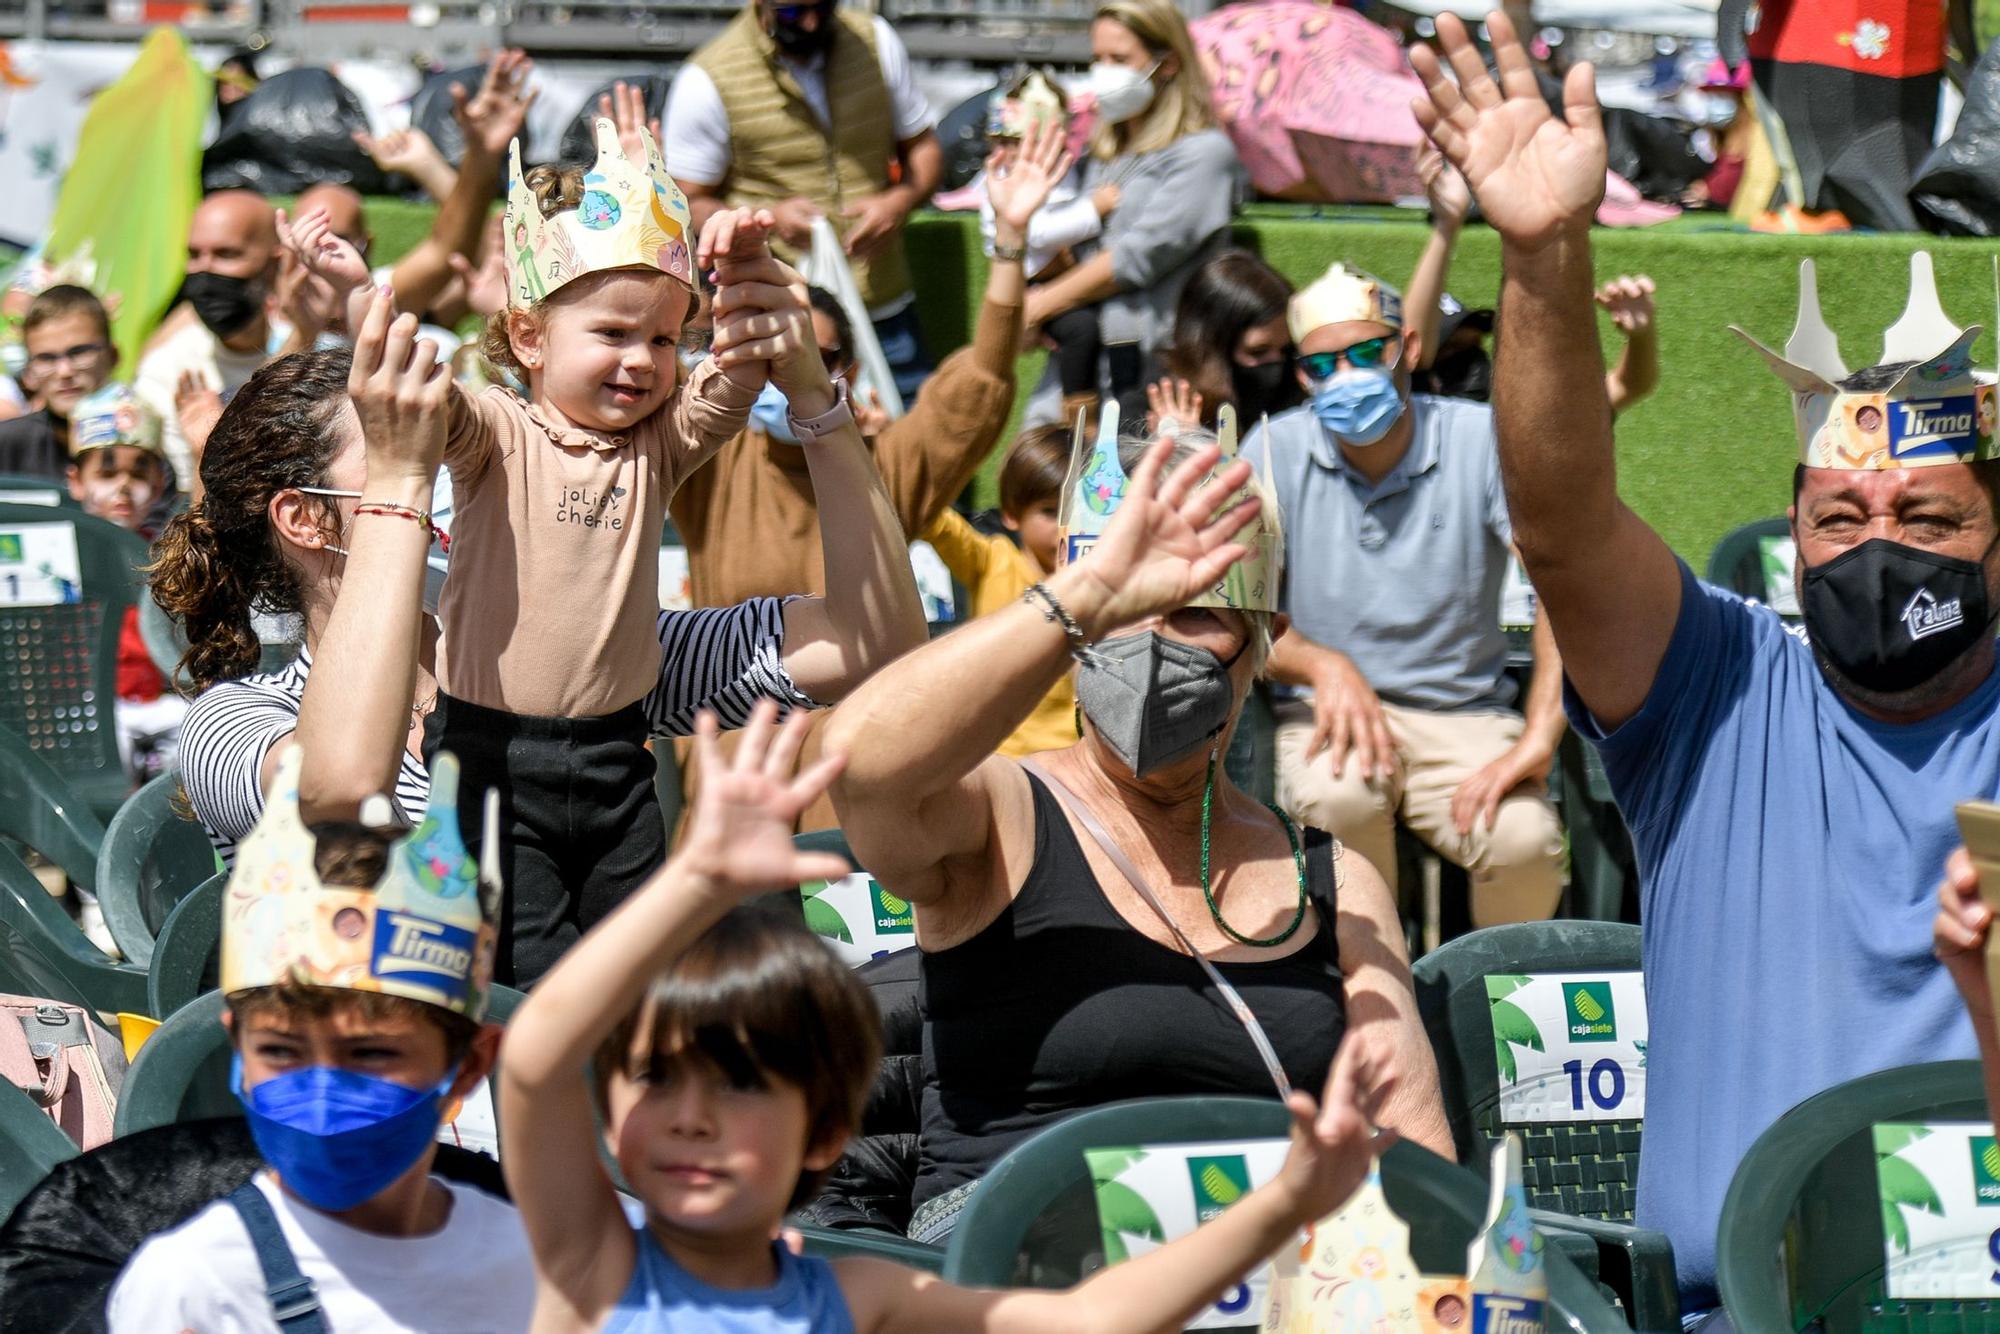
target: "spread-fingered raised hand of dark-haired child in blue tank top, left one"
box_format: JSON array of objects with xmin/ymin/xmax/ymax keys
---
[{"xmin": 674, "ymin": 700, "xmax": 848, "ymax": 900}]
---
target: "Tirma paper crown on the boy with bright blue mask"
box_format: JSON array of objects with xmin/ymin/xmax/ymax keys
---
[{"xmin": 222, "ymin": 746, "xmax": 500, "ymax": 1020}]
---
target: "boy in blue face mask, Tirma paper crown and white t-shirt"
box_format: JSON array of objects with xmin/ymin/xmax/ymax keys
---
[{"xmin": 110, "ymin": 748, "xmax": 534, "ymax": 1334}]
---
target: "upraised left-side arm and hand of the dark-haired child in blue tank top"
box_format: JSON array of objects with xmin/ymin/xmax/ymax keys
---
[{"xmin": 500, "ymin": 702, "xmax": 848, "ymax": 1328}]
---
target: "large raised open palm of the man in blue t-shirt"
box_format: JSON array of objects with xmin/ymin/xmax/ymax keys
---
[{"xmin": 1410, "ymin": 14, "xmax": 1606, "ymax": 246}]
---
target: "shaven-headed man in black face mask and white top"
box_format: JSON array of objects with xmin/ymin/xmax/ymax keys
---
[{"xmin": 134, "ymin": 190, "xmax": 278, "ymax": 488}]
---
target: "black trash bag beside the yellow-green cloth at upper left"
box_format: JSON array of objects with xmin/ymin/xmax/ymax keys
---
[{"xmin": 202, "ymin": 68, "xmax": 386, "ymax": 194}]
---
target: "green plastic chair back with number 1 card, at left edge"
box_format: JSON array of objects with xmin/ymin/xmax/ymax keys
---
[{"xmin": 0, "ymin": 504, "xmax": 150, "ymax": 820}]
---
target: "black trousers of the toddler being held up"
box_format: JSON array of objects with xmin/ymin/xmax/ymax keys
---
[{"xmin": 424, "ymin": 694, "xmax": 666, "ymax": 988}]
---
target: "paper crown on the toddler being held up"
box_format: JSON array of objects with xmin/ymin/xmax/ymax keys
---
[{"xmin": 502, "ymin": 116, "xmax": 694, "ymax": 310}]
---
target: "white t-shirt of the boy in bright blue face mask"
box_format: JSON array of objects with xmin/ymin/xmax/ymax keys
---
[{"xmin": 110, "ymin": 1172, "xmax": 534, "ymax": 1334}]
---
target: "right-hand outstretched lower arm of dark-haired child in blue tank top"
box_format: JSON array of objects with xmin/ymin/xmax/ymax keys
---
[{"xmin": 838, "ymin": 1034, "xmax": 1394, "ymax": 1334}]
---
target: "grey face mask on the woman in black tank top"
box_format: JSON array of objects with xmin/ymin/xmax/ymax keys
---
[{"xmin": 1076, "ymin": 630, "xmax": 1242, "ymax": 778}]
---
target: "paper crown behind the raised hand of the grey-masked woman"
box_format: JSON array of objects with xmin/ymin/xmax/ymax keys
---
[{"xmin": 1058, "ymin": 402, "xmax": 1284, "ymax": 612}]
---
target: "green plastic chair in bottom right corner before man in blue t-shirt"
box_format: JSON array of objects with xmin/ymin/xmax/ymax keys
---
[{"xmin": 1716, "ymin": 1060, "xmax": 2000, "ymax": 1334}]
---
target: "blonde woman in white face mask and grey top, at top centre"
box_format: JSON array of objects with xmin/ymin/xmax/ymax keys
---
[{"xmin": 1024, "ymin": 0, "xmax": 1246, "ymax": 420}]
